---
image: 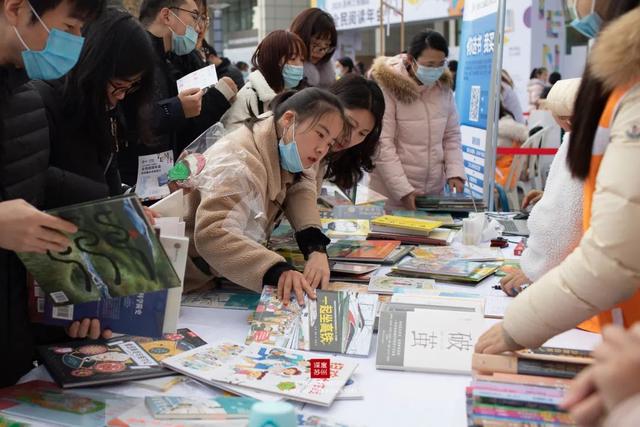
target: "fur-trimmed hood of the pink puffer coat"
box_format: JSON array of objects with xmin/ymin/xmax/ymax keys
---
[{"xmin": 371, "ymin": 54, "xmax": 453, "ymax": 104}]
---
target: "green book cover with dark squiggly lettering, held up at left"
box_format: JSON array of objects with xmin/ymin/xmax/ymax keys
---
[{"xmin": 18, "ymin": 194, "xmax": 180, "ymax": 304}]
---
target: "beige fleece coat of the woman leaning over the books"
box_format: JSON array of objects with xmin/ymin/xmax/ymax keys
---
[{"xmin": 185, "ymin": 113, "xmax": 321, "ymax": 292}]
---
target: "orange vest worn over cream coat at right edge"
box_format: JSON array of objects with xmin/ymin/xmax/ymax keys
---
[{"xmin": 578, "ymin": 82, "xmax": 640, "ymax": 332}]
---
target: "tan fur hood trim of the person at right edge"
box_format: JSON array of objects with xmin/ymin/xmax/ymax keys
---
[{"xmin": 589, "ymin": 7, "xmax": 640, "ymax": 90}]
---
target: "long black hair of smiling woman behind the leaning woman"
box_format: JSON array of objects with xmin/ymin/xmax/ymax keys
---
[{"xmin": 325, "ymin": 74, "xmax": 385, "ymax": 189}]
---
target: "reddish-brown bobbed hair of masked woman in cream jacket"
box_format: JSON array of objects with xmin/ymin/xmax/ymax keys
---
[{"xmin": 251, "ymin": 30, "xmax": 307, "ymax": 93}]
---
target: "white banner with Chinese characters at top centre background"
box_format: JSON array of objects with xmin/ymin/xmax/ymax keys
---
[{"xmin": 311, "ymin": 0, "xmax": 464, "ymax": 30}]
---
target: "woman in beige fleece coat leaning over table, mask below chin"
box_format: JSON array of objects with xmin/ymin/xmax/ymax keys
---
[{"xmin": 186, "ymin": 88, "xmax": 346, "ymax": 304}]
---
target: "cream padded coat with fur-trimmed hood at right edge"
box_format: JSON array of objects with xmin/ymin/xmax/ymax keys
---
[{"xmin": 504, "ymin": 8, "xmax": 640, "ymax": 347}]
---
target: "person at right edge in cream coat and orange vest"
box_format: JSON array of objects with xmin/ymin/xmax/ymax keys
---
[{"xmin": 476, "ymin": 2, "xmax": 640, "ymax": 353}]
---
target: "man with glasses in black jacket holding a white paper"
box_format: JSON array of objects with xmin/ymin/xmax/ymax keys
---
[{"xmin": 118, "ymin": 0, "xmax": 234, "ymax": 185}]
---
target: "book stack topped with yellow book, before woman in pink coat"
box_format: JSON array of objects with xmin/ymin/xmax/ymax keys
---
[{"xmin": 367, "ymin": 215, "xmax": 453, "ymax": 245}]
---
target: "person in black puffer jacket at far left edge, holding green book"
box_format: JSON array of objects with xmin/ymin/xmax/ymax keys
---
[{"xmin": 0, "ymin": 0, "xmax": 103, "ymax": 387}]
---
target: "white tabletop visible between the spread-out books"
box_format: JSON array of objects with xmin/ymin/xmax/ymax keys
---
[{"xmin": 23, "ymin": 277, "xmax": 600, "ymax": 427}]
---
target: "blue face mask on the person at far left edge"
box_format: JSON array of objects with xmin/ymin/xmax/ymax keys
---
[{"xmin": 13, "ymin": 4, "xmax": 84, "ymax": 80}]
